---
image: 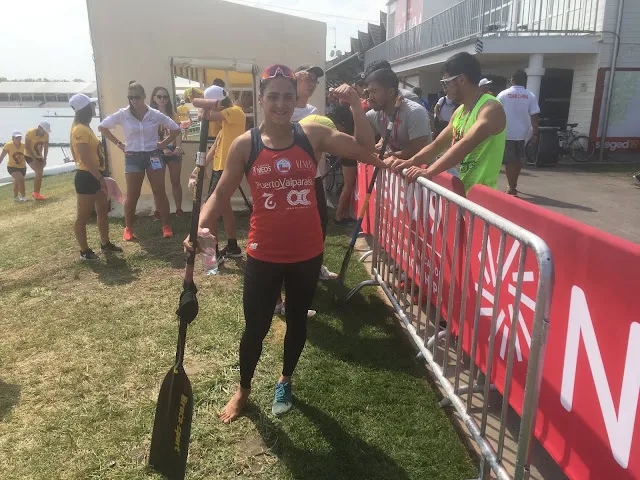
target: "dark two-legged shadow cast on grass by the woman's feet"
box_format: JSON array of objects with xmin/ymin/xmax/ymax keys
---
[{"xmin": 245, "ymin": 397, "xmax": 409, "ymax": 480}]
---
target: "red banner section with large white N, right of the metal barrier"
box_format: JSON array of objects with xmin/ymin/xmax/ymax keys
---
[{"xmin": 468, "ymin": 186, "xmax": 640, "ymax": 480}]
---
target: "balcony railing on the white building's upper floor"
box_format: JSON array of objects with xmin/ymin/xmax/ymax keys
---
[{"xmin": 365, "ymin": 0, "xmax": 599, "ymax": 66}]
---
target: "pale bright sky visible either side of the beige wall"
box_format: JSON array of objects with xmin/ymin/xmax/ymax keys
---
[{"xmin": 0, "ymin": 0, "xmax": 386, "ymax": 81}]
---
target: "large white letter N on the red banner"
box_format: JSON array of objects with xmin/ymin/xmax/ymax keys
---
[{"xmin": 560, "ymin": 286, "xmax": 640, "ymax": 468}]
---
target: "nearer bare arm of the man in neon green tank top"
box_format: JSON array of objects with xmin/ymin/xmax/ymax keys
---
[{"xmin": 407, "ymin": 102, "xmax": 507, "ymax": 181}]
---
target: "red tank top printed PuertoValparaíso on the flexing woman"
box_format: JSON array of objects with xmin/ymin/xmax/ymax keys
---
[{"xmin": 246, "ymin": 123, "xmax": 324, "ymax": 263}]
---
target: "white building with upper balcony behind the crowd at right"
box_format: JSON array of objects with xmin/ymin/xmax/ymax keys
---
[{"xmin": 365, "ymin": 0, "xmax": 640, "ymax": 151}]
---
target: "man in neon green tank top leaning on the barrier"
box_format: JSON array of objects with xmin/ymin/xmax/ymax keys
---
[{"xmin": 387, "ymin": 52, "xmax": 507, "ymax": 192}]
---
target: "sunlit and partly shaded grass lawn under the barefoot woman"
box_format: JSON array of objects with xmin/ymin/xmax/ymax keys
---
[{"xmin": 0, "ymin": 174, "xmax": 476, "ymax": 480}]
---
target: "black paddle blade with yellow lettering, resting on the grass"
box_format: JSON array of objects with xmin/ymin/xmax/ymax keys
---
[{"xmin": 149, "ymin": 366, "xmax": 193, "ymax": 480}]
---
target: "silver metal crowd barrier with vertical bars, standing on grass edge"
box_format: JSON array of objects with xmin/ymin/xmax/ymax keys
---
[{"xmin": 345, "ymin": 171, "xmax": 553, "ymax": 480}]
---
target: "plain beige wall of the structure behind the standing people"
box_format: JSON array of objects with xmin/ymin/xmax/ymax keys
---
[{"xmin": 87, "ymin": 0, "xmax": 326, "ymax": 214}]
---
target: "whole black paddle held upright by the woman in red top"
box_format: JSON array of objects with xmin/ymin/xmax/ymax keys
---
[{"xmin": 149, "ymin": 108, "xmax": 209, "ymax": 480}]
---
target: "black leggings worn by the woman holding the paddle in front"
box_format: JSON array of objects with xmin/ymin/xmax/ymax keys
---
[{"xmin": 240, "ymin": 255, "xmax": 322, "ymax": 388}]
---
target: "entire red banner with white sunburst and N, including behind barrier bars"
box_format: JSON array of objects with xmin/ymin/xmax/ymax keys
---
[{"xmin": 359, "ymin": 167, "xmax": 640, "ymax": 480}]
